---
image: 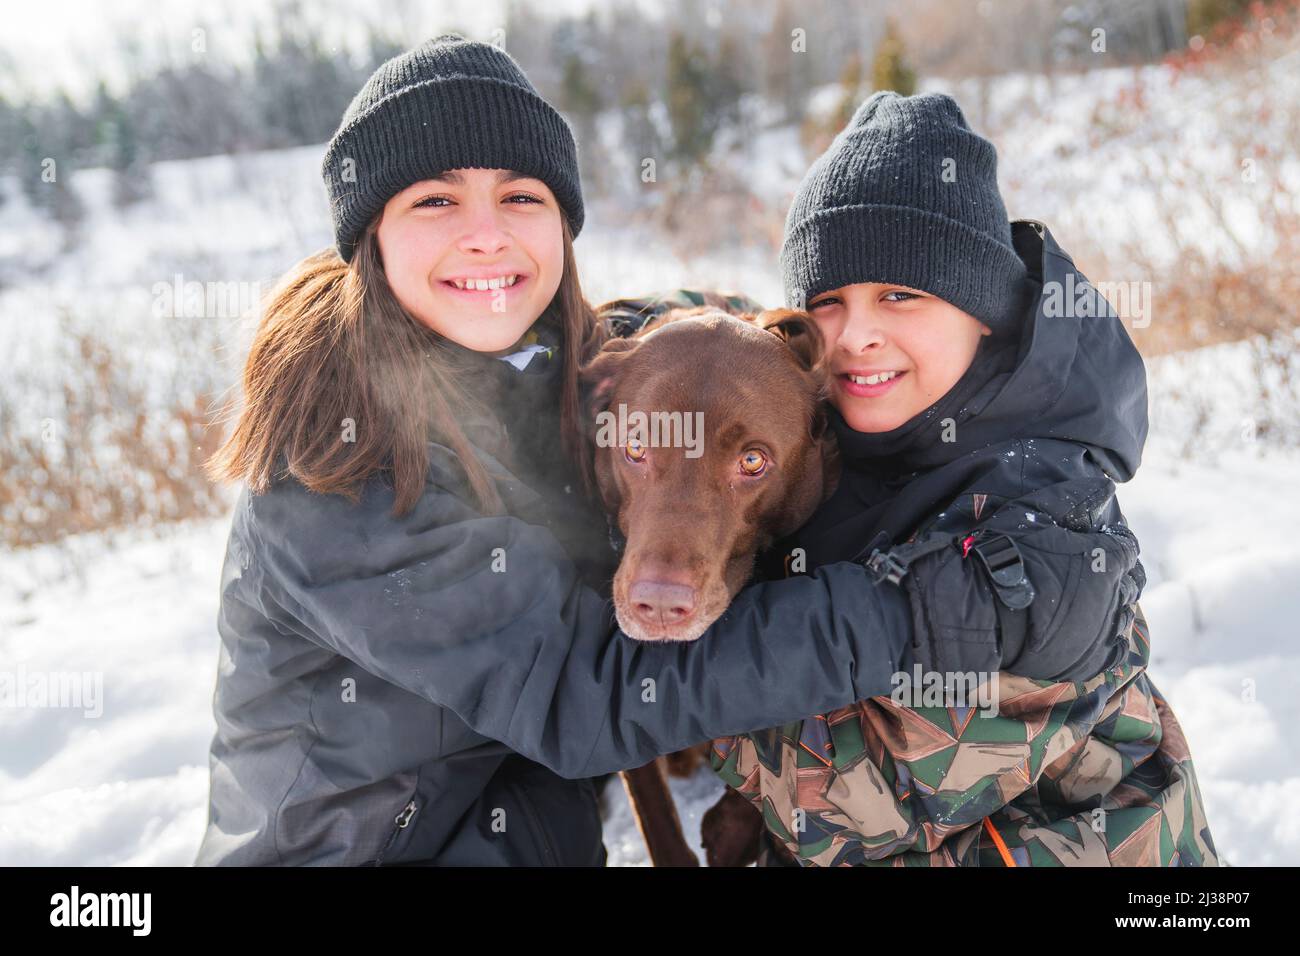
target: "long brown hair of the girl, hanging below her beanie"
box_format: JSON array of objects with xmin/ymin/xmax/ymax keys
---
[{"xmin": 207, "ymin": 217, "xmax": 603, "ymax": 515}]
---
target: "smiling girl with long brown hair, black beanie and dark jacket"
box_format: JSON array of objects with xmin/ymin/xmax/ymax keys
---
[{"xmin": 198, "ymin": 36, "xmax": 1123, "ymax": 865}]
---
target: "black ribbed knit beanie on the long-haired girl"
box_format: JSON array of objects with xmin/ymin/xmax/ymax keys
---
[{"xmin": 321, "ymin": 34, "xmax": 584, "ymax": 261}]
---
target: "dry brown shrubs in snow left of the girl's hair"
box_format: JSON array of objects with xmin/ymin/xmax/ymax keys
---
[{"xmin": 0, "ymin": 306, "xmax": 228, "ymax": 549}]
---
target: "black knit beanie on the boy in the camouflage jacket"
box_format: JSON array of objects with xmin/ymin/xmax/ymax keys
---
[{"xmin": 781, "ymin": 91, "xmax": 1027, "ymax": 333}]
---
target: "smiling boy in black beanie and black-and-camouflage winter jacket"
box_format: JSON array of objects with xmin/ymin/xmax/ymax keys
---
[{"xmin": 712, "ymin": 92, "xmax": 1217, "ymax": 866}]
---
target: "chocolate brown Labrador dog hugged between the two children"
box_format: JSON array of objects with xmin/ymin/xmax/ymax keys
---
[{"xmin": 582, "ymin": 306, "xmax": 839, "ymax": 866}]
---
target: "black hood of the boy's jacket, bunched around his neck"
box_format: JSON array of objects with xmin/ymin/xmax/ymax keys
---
[{"xmin": 831, "ymin": 220, "xmax": 1148, "ymax": 481}]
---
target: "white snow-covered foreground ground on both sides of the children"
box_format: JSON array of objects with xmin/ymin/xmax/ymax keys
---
[{"xmin": 0, "ymin": 426, "xmax": 1300, "ymax": 865}]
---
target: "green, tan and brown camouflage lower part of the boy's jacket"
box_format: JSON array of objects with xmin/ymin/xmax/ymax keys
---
[{"xmin": 711, "ymin": 607, "xmax": 1218, "ymax": 866}]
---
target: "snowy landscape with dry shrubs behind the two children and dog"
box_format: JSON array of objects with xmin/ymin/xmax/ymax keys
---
[{"xmin": 0, "ymin": 3, "xmax": 1300, "ymax": 866}]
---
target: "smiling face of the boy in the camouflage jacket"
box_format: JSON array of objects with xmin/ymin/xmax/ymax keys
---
[{"xmin": 809, "ymin": 282, "xmax": 992, "ymax": 432}]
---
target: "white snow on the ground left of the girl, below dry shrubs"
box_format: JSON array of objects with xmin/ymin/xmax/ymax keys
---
[{"xmin": 0, "ymin": 522, "xmax": 225, "ymax": 866}]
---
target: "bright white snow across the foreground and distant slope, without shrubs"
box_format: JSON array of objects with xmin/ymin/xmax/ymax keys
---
[{"xmin": 0, "ymin": 55, "xmax": 1300, "ymax": 866}]
